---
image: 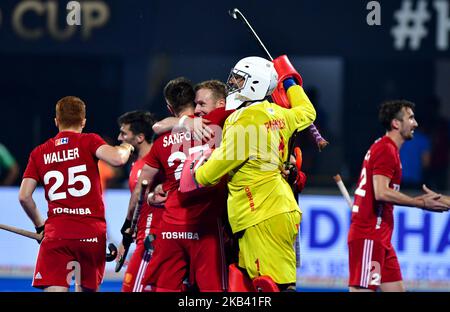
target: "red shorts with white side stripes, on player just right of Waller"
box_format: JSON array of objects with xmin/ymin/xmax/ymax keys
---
[{"xmin": 122, "ymin": 240, "xmax": 157, "ymax": 292}]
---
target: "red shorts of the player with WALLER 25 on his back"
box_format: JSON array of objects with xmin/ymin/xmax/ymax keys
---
[{"xmin": 32, "ymin": 235, "xmax": 106, "ymax": 290}]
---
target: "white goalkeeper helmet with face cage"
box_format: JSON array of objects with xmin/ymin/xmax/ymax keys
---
[{"xmin": 225, "ymin": 56, "xmax": 278, "ymax": 110}]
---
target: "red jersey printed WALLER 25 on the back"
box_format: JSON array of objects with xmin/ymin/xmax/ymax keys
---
[{"xmin": 23, "ymin": 131, "xmax": 106, "ymax": 239}]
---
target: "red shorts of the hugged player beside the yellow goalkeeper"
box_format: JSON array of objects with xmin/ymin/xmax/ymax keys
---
[{"xmin": 144, "ymin": 221, "xmax": 226, "ymax": 292}]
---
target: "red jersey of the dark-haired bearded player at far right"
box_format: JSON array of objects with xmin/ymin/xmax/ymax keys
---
[{"xmin": 348, "ymin": 136, "xmax": 402, "ymax": 246}]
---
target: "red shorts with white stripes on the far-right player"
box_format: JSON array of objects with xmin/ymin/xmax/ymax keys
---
[{"xmin": 348, "ymin": 239, "xmax": 402, "ymax": 290}]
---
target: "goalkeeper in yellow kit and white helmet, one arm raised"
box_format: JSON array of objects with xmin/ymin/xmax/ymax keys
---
[{"xmin": 181, "ymin": 57, "xmax": 316, "ymax": 291}]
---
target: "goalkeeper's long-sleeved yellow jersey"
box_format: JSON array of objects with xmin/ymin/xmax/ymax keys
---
[{"xmin": 196, "ymin": 86, "xmax": 316, "ymax": 233}]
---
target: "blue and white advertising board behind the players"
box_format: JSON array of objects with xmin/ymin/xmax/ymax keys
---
[{"xmin": 0, "ymin": 188, "xmax": 450, "ymax": 291}]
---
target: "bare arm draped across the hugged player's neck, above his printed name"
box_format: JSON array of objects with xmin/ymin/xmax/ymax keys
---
[{"xmin": 153, "ymin": 116, "xmax": 214, "ymax": 140}]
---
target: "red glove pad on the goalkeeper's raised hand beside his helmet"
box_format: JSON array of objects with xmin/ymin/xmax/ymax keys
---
[{"xmin": 272, "ymin": 55, "xmax": 303, "ymax": 108}]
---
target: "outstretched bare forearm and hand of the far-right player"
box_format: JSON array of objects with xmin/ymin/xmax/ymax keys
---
[{"xmin": 373, "ymin": 175, "xmax": 448, "ymax": 212}]
